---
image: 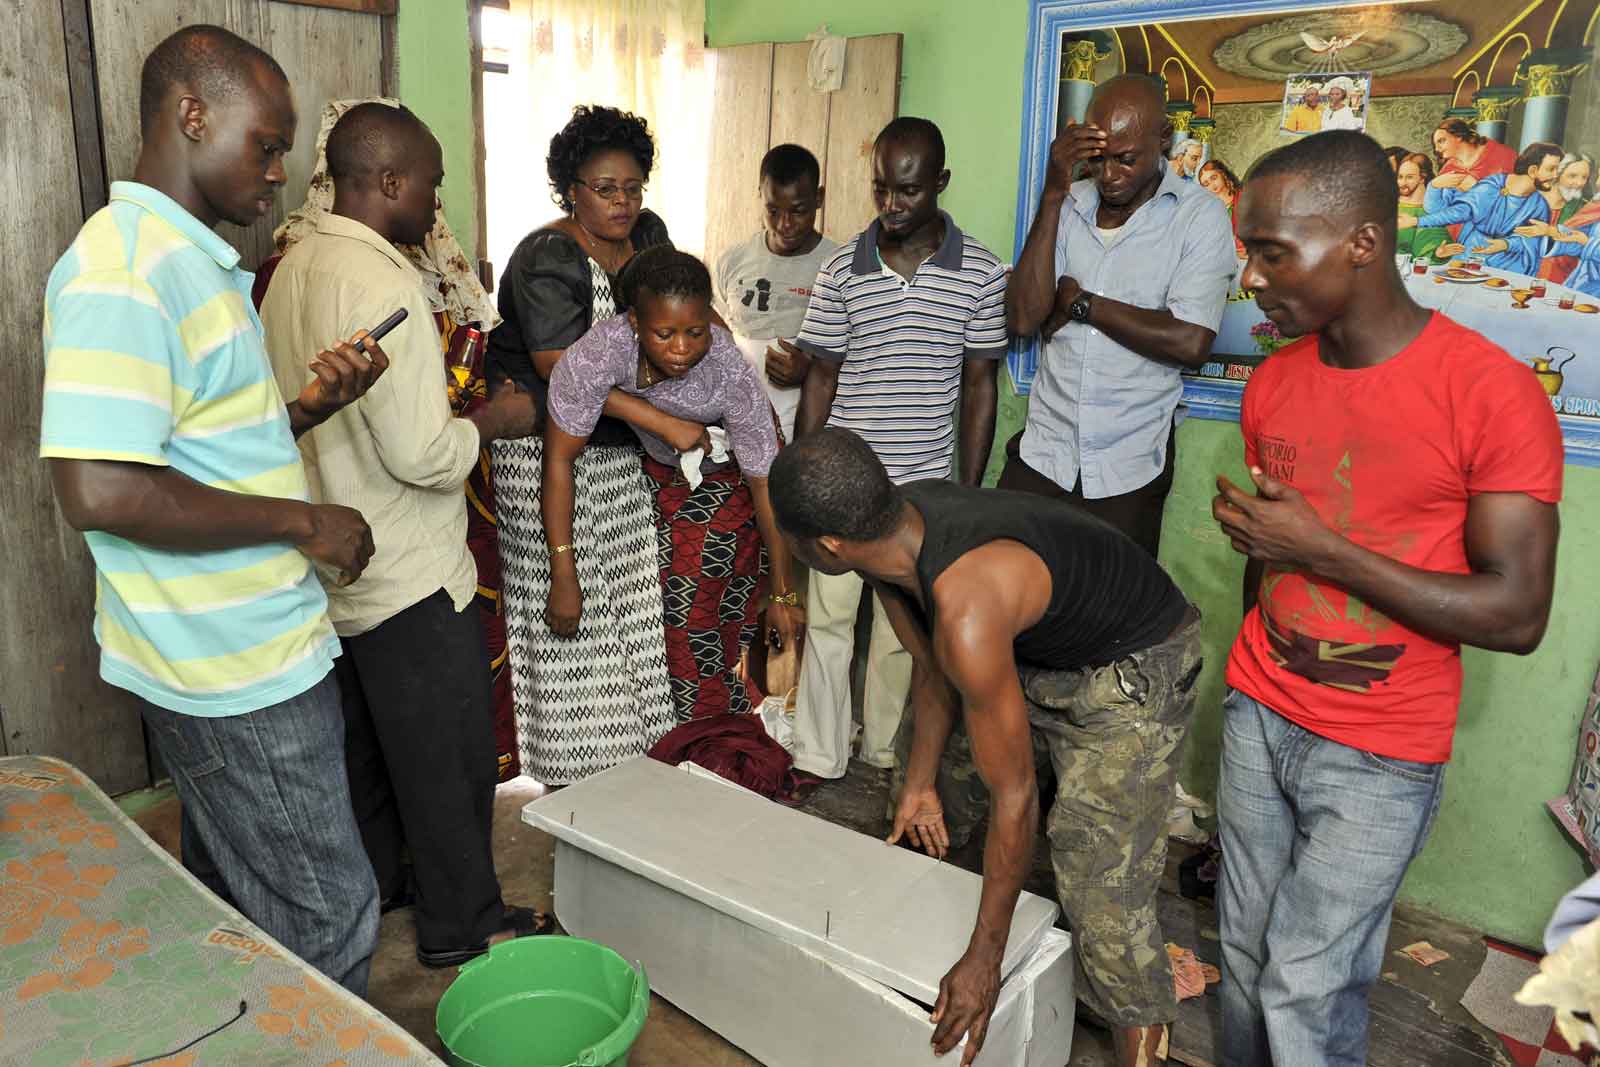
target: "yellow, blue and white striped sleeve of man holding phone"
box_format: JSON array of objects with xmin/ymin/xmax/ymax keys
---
[{"xmin": 38, "ymin": 269, "xmax": 189, "ymax": 466}]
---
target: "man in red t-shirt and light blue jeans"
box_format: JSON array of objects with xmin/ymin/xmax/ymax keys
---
[{"xmin": 1213, "ymin": 131, "xmax": 1562, "ymax": 1067}]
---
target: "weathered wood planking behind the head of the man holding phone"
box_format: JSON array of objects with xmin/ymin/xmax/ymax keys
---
[{"xmin": 91, "ymin": 0, "xmax": 384, "ymax": 269}]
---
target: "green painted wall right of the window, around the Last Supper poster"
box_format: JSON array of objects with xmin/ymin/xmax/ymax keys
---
[{"xmin": 706, "ymin": 0, "xmax": 1600, "ymax": 944}]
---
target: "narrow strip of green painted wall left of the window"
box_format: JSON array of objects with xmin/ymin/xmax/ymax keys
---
[{"xmin": 395, "ymin": 0, "xmax": 478, "ymax": 256}]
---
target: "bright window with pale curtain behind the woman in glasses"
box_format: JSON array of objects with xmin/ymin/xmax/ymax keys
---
[{"xmin": 483, "ymin": 0, "xmax": 715, "ymax": 278}]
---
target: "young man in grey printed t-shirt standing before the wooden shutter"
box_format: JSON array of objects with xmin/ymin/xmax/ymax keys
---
[{"xmin": 712, "ymin": 144, "xmax": 838, "ymax": 442}]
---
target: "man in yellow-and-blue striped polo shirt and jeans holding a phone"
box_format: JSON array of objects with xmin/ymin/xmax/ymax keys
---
[{"xmin": 40, "ymin": 26, "xmax": 387, "ymax": 993}]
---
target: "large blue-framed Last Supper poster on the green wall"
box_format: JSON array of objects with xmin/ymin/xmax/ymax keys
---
[{"xmin": 1011, "ymin": 0, "xmax": 1600, "ymax": 462}]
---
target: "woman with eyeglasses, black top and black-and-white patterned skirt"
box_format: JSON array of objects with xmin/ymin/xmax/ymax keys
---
[{"xmin": 486, "ymin": 106, "xmax": 706, "ymax": 785}]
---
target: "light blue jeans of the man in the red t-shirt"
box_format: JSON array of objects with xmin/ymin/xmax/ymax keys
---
[{"xmin": 1216, "ymin": 691, "xmax": 1445, "ymax": 1067}]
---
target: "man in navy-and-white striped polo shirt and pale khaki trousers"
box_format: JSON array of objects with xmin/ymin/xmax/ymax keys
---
[{"xmin": 795, "ymin": 117, "xmax": 1006, "ymax": 777}]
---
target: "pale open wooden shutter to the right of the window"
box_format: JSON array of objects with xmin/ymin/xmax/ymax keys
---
[{"xmin": 706, "ymin": 34, "xmax": 901, "ymax": 262}]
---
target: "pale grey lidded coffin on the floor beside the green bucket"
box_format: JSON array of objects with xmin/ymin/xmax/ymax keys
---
[{"xmin": 523, "ymin": 760, "xmax": 1074, "ymax": 1067}]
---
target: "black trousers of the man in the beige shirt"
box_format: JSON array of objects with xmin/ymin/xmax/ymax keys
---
[{"xmin": 336, "ymin": 589, "xmax": 506, "ymax": 950}]
